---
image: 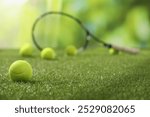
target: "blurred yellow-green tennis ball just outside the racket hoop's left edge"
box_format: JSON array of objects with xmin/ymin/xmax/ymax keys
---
[{"xmin": 19, "ymin": 44, "xmax": 33, "ymax": 56}]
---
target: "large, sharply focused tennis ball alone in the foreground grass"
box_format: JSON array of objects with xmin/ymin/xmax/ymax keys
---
[{"xmin": 9, "ymin": 60, "xmax": 32, "ymax": 81}]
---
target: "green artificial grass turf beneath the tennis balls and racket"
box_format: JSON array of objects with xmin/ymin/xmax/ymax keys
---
[{"xmin": 0, "ymin": 49, "xmax": 150, "ymax": 99}]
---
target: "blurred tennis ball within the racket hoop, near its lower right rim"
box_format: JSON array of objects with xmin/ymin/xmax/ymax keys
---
[{"xmin": 66, "ymin": 45, "xmax": 78, "ymax": 56}]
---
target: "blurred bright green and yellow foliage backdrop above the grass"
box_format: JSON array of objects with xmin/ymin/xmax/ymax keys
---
[{"xmin": 0, "ymin": 0, "xmax": 150, "ymax": 48}]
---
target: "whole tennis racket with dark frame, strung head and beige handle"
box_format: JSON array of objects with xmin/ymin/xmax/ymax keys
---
[{"xmin": 32, "ymin": 11, "xmax": 139, "ymax": 54}]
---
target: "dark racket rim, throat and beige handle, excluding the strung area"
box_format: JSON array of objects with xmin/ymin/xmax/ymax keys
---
[{"xmin": 32, "ymin": 11, "xmax": 139, "ymax": 54}]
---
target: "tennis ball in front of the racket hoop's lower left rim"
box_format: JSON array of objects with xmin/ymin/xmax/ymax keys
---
[{"xmin": 41, "ymin": 48, "xmax": 56, "ymax": 60}]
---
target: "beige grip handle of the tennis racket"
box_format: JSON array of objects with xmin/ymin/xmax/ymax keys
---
[{"xmin": 111, "ymin": 45, "xmax": 140, "ymax": 54}]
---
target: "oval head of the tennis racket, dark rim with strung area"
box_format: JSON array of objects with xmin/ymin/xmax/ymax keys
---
[{"xmin": 32, "ymin": 12, "xmax": 87, "ymax": 50}]
